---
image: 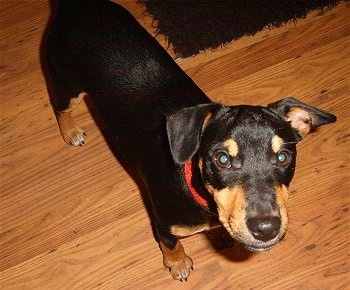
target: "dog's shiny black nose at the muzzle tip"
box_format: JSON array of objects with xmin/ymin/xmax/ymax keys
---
[{"xmin": 247, "ymin": 216, "xmax": 281, "ymax": 242}]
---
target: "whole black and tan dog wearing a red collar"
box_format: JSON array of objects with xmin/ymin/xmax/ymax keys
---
[{"xmin": 46, "ymin": 0, "xmax": 336, "ymax": 281}]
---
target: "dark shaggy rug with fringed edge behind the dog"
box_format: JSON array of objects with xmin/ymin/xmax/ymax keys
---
[{"xmin": 139, "ymin": 0, "xmax": 340, "ymax": 57}]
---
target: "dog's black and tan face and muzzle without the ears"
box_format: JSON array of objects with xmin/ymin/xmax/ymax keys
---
[{"xmin": 198, "ymin": 106, "xmax": 298, "ymax": 251}]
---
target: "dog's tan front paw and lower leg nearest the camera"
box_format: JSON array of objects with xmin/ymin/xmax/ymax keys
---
[{"xmin": 158, "ymin": 227, "xmax": 193, "ymax": 282}]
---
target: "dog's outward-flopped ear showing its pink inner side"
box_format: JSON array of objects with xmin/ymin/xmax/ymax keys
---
[{"xmin": 268, "ymin": 98, "xmax": 337, "ymax": 138}]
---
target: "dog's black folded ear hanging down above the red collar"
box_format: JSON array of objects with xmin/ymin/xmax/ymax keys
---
[{"xmin": 166, "ymin": 104, "xmax": 218, "ymax": 164}]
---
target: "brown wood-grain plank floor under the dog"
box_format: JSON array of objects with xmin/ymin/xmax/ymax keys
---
[{"xmin": 0, "ymin": 0, "xmax": 350, "ymax": 289}]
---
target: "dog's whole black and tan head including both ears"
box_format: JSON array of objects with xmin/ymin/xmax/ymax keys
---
[{"xmin": 167, "ymin": 98, "xmax": 336, "ymax": 251}]
